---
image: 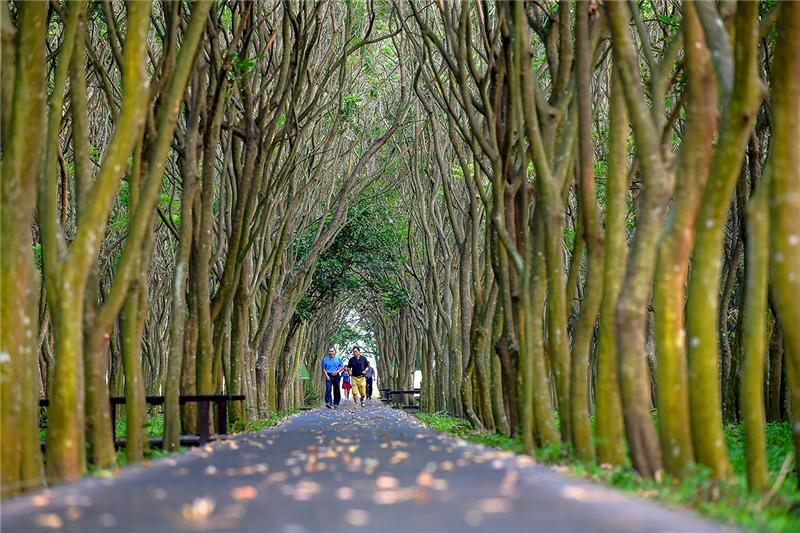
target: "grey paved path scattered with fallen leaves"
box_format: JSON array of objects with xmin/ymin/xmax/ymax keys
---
[{"xmin": 1, "ymin": 401, "xmax": 723, "ymax": 533}]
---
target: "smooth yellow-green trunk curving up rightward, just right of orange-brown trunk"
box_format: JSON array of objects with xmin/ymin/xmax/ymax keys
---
[{"xmin": 686, "ymin": 2, "xmax": 760, "ymax": 479}]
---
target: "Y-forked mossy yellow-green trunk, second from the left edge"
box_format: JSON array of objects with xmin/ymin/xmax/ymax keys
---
[{"xmin": 39, "ymin": 2, "xmax": 150, "ymax": 481}]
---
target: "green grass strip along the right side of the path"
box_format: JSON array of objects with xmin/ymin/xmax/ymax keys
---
[{"xmin": 417, "ymin": 413, "xmax": 800, "ymax": 532}]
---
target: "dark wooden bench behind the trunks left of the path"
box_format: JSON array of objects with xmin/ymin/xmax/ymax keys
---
[{"xmin": 39, "ymin": 394, "xmax": 244, "ymax": 446}]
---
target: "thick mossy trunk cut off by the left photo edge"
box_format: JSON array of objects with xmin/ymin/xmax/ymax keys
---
[{"xmin": 0, "ymin": 2, "xmax": 48, "ymax": 497}]
